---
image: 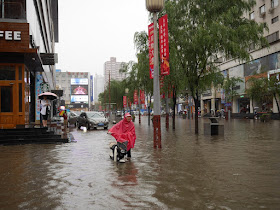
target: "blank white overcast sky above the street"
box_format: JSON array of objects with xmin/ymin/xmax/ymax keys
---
[{"xmin": 56, "ymin": 0, "xmax": 149, "ymax": 75}]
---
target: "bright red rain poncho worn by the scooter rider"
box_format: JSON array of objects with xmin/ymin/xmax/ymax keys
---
[{"xmin": 109, "ymin": 113, "xmax": 136, "ymax": 151}]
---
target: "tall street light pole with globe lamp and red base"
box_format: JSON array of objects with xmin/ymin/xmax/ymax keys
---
[{"xmin": 146, "ymin": 0, "xmax": 164, "ymax": 148}]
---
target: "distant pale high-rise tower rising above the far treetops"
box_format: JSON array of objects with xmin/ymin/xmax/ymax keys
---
[{"xmin": 104, "ymin": 57, "xmax": 126, "ymax": 88}]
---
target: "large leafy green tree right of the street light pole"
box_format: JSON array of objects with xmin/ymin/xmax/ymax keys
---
[{"xmin": 165, "ymin": 0, "xmax": 267, "ymax": 133}]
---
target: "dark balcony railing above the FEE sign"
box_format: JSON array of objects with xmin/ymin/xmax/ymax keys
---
[{"xmin": 0, "ymin": 2, "xmax": 26, "ymax": 19}]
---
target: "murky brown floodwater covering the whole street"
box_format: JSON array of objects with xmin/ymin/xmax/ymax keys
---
[{"xmin": 0, "ymin": 117, "xmax": 280, "ymax": 210}]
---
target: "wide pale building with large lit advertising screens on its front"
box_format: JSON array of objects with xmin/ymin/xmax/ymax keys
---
[{"xmin": 56, "ymin": 70, "xmax": 91, "ymax": 110}]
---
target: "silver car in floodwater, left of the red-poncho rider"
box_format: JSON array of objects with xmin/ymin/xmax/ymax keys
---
[{"xmin": 77, "ymin": 111, "xmax": 109, "ymax": 130}]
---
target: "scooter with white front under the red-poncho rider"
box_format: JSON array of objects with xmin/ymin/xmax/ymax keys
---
[{"xmin": 110, "ymin": 141, "xmax": 128, "ymax": 163}]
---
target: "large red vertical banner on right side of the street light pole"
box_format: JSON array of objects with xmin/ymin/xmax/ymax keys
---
[{"xmin": 158, "ymin": 14, "xmax": 170, "ymax": 75}]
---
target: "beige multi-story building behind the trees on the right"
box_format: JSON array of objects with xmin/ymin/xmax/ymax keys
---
[{"xmin": 201, "ymin": 0, "xmax": 280, "ymax": 113}]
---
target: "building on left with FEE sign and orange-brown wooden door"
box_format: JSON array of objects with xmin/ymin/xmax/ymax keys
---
[{"xmin": 0, "ymin": 0, "xmax": 58, "ymax": 128}]
